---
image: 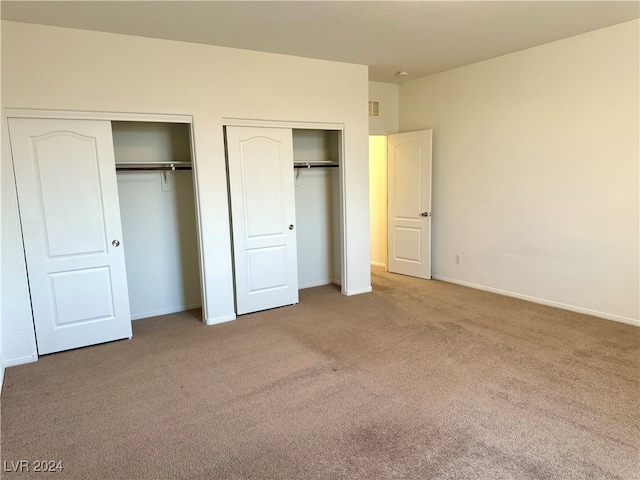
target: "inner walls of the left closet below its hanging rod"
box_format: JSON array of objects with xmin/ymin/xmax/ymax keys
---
[{"xmin": 118, "ymin": 171, "xmax": 201, "ymax": 320}]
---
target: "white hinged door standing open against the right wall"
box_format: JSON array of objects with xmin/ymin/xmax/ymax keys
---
[{"xmin": 387, "ymin": 130, "xmax": 432, "ymax": 278}]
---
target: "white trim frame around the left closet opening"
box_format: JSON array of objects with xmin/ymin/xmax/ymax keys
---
[{"xmin": 2, "ymin": 108, "xmax": 207, "ymax": 330}]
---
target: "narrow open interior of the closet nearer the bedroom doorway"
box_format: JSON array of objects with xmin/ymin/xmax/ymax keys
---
[{"xmin": 293, "ymin": 129, "xmax": 342, "ymax": 289}]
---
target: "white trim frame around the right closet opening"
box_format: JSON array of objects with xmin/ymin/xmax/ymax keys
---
[{"xmin": 222, "ymin": 117, "xmax": 350, "ymax": 295}]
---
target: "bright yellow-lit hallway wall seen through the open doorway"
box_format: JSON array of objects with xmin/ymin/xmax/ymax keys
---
[{"xmin": 369, "ymin": 135, "xmax": 387, "ymax": 267}]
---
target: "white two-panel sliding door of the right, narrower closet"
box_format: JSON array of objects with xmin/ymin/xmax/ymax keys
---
[{"xmin": 227, "ymin": 127, "xmax": 298, "ymax": 315}]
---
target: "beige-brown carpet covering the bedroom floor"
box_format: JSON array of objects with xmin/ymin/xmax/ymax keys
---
[{"xmin": 2, "ymin": 269, "xmax": 640, "ymax": 480}]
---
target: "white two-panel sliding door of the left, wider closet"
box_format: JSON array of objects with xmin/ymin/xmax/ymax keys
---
[{"xmin": 9, "ymin": 118, "xmax": 131, "ymax": 355}]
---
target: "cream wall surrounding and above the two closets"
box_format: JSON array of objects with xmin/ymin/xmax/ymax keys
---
[{"xmin": 2, "ymin": 22, "xmax": 371, "ymax": 364}]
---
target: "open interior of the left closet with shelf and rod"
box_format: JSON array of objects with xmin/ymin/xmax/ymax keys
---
[{"xmin": 111, "ymin": 121, "xmax": 202, "ymax": 320}]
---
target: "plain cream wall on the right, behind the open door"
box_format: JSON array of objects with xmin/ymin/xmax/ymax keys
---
[{"xmin": 400, "ymin": 20, "xmax": 640, "ymax": 324}]
